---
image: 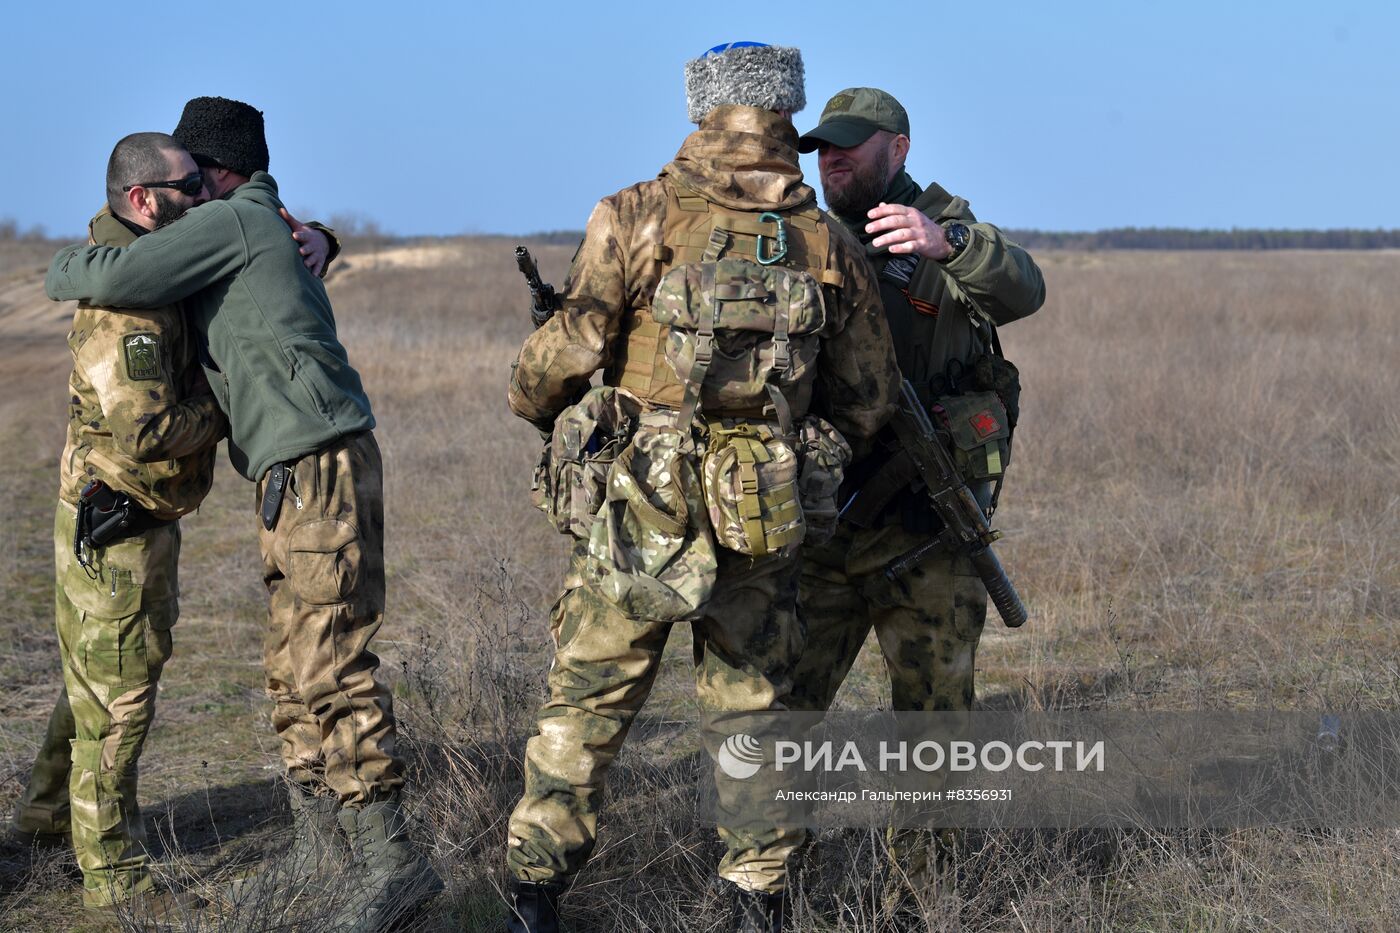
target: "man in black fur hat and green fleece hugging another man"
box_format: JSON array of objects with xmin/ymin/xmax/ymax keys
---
[{"xmin": 46, "ymin": 97, "xmax": 442, "ymax": 930}]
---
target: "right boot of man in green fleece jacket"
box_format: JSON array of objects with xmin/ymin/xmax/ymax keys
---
[{"xmin": 333, "ymin": 792, "xmax": 442, "ymax": 933}]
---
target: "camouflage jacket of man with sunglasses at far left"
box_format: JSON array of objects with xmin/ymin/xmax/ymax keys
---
[{"xmin": 59, "ymin": 209, "xmax": 228, "ymax": 518}]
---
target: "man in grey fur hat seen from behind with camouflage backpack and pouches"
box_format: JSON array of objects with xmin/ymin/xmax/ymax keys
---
[{"xmin": 505, "ymin": 42, "xmax": 897, "ymax": 933}]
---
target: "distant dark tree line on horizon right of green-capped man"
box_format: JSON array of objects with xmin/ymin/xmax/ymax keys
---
[{"xmin": 1007, "ymin": 227, "xmax": 1400, "ymax": 249}]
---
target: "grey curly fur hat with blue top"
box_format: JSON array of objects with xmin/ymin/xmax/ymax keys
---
[{"xmin": 686, "ymin": 42, "xmax": 806, "ymax": 123}]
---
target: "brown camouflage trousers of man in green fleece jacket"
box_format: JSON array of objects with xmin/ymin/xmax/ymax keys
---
[{"xmin": 258, "ymin": 431, "xmax": 403, "ymax": 806}]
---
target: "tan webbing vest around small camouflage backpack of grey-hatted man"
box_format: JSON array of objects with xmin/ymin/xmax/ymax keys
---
[{"xmin": 608, "ymin": 184, "xmax": 844, "ymax": 406}]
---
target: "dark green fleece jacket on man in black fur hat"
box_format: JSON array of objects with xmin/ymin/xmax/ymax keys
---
[{"xmin": 45, "ymin": 172, "xmax": 374, "ymax": 479}]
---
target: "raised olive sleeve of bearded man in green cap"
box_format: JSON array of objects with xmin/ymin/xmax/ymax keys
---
[{"xmin": 937, "ymin": 198, "xmax": 1046, "ymax": 326}]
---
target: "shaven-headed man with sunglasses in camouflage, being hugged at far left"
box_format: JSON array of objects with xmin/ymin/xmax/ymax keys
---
[{"xmin": 7, "ymin": 133, "xmax": 227, "ymax": 908}]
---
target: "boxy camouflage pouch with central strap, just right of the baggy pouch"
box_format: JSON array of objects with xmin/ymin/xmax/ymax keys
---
[{"xmin": 700, "ymin": 419, "xmax": 806, "ymax": 558}]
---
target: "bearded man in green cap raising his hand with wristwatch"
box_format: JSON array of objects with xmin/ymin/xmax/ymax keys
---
[{"xmin": 788, "ymin": 87, "xmax": 1044, "ymax": 902}]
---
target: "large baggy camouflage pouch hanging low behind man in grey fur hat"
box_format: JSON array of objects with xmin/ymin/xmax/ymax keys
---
[{"xmin": 584, "ymin": 412, "xmax": 718, "ymax": 622}]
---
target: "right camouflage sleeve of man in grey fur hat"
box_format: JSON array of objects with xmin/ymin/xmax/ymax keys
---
[{"xmin": 818, "ymin": 221, "xmax": 900, "ymax": 451}]
